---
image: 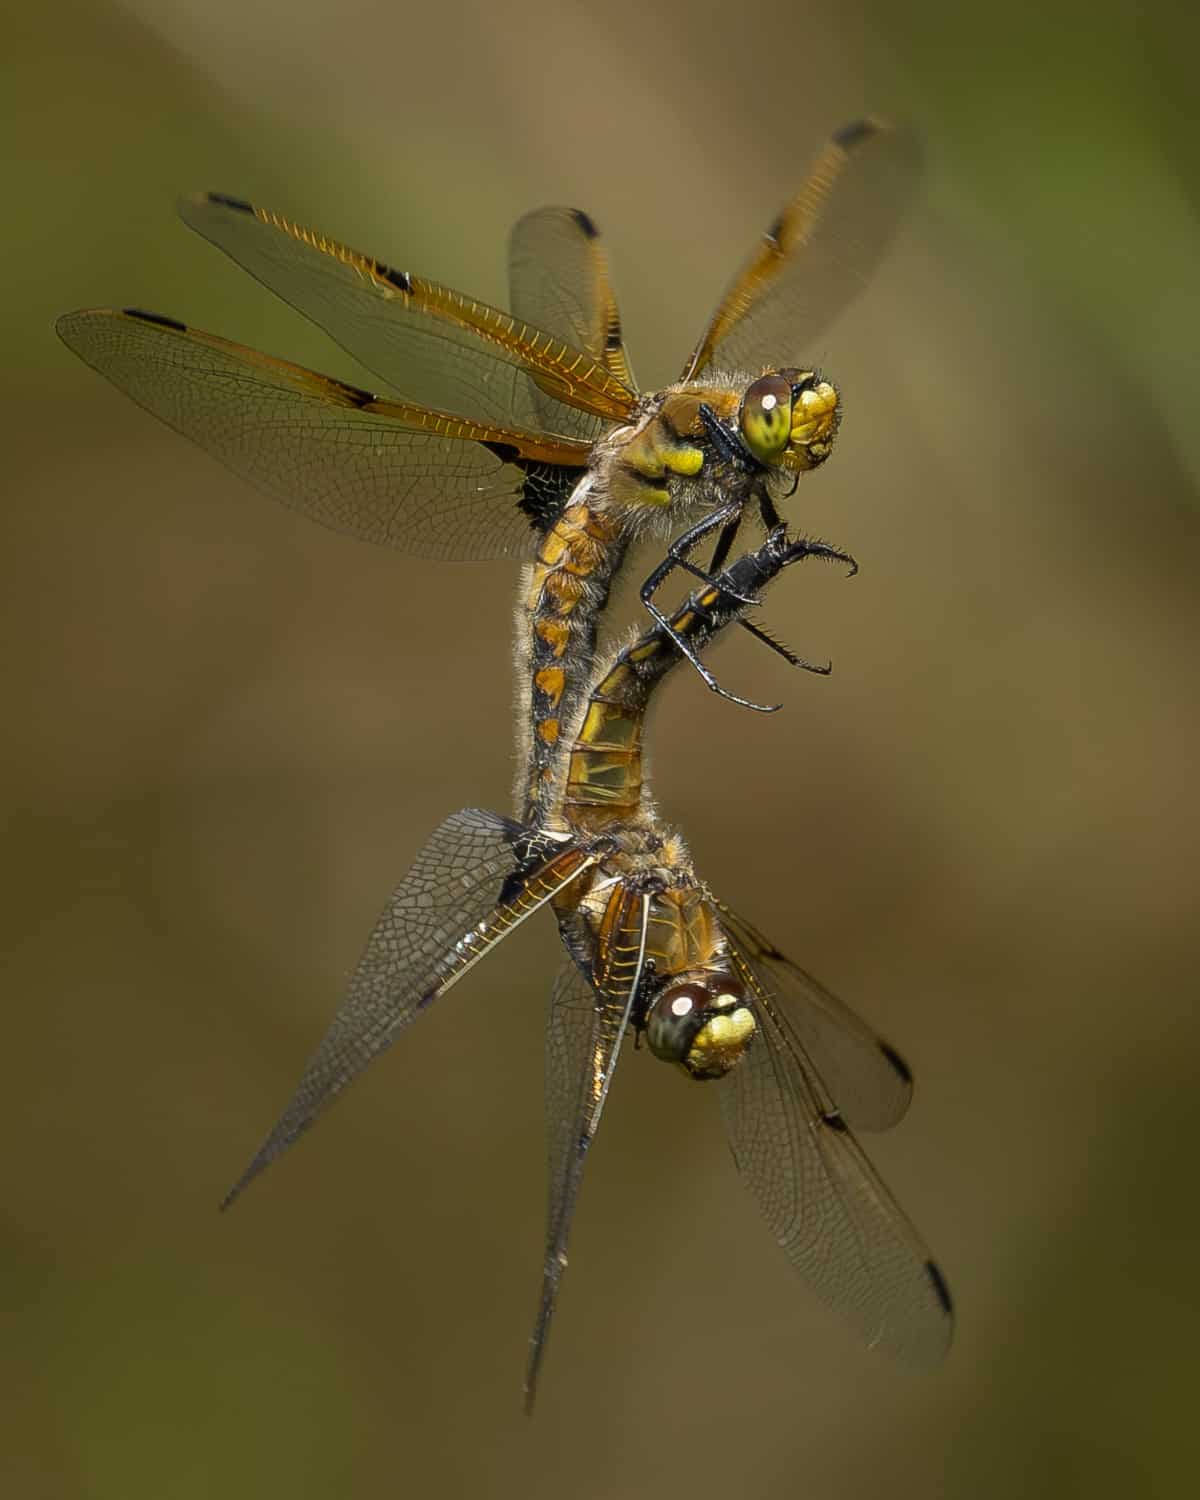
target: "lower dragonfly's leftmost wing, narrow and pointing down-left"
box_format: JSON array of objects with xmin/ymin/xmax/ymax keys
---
[{"xmin": 222, "ymin": 807, "xmax": 594, "ymax": 1208}]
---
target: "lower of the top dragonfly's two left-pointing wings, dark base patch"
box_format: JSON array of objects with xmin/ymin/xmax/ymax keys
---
[{"xmin": 57, "ymin": 309, "xmax": 588, "ymax": 558}]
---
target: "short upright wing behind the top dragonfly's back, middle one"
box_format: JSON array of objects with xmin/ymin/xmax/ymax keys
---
[{"xmin": 509, "ymin": 207, "xmax": 633, "ymax": 441}]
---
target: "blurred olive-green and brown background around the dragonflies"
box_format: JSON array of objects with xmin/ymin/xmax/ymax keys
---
[{"xmin": 0, "ymin": 0, "xmax": 1200, "ymax": 1500}]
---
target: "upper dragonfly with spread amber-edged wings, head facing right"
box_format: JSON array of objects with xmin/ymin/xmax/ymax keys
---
[{"xmin": 57, "ymin": 119, "xmax": 921, "ymax": 822}]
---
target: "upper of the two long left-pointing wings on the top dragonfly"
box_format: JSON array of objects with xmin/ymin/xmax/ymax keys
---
[{"xmin": 179, "ymin": 194, "xmax": 635, "ymax": 432}]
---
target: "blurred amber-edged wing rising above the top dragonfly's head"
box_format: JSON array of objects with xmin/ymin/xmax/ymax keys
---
[{"xmin": 684, "ymin": 119, "xmax": 923, "ymax": 380}]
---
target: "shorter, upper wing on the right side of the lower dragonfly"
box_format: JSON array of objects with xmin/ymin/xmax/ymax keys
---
[{"xmin": 717, "ymin": 902, "xmax": 912, "ymax": 1130}]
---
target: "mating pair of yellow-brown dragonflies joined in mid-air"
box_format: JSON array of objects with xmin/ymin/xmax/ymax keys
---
[{"xmin": 59, "ymin": 120, "xmax": 953, "ymax": 1404}]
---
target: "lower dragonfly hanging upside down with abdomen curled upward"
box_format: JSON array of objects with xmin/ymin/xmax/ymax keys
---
[{"xmin": 225, "ymin": 525, "xmax": 953, "ymax": 1410}]
